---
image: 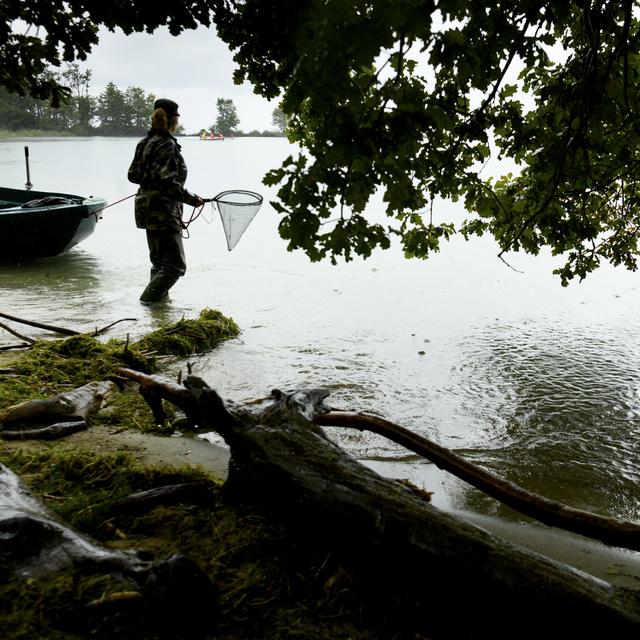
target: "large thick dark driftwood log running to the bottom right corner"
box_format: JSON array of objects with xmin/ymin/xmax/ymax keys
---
[{"xmin": 119, "ymin": 369, "xmax": 640, "ymax": 638}]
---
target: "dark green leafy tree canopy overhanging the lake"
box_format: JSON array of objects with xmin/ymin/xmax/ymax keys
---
[{"xmin": 5, "ymin": 0, "xmax": 640, "ymax": 283}]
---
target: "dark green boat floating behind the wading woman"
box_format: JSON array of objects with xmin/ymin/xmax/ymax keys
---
[{"xmin": 0, "ymin": 187, "xmax": 107, "ymax": 261}]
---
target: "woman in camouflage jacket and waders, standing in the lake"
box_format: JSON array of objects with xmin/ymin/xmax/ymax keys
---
[{"xmin": 127, "ymin": 98, "xmax": 204, "ymax": 304}]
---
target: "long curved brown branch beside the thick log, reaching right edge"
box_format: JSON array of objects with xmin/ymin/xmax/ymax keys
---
[{"xmin": 314, "ymin": 411, "xmax": 640, "ymax": 551}]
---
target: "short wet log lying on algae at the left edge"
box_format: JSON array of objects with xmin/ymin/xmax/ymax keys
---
[{"xmin": 0, "ymin": 380, "xmax": 117, "ymax": 440}]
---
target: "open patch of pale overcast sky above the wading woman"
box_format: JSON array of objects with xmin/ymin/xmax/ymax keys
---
[{"xmin": 84, "ymin": 28, "xmax": 277, "ymax": 133}]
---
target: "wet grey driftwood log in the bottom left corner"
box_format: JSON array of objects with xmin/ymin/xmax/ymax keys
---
[{"xmin": 0, "ymin": 464, "xmax": 215, "ymax": 638}]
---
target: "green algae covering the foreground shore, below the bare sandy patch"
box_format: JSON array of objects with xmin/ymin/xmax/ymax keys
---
[{"xmin": 0, "ymin": 442, "xmax": 412, "ymax": 640}]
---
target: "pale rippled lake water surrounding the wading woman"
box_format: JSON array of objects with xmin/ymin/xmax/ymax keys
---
[{"xmin": 0, "ymin": 132, "xmax": 640, "ymax": 564}]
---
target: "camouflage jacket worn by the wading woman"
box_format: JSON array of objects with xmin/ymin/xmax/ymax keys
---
[{"xmin": 127, "ymin": 129, "xmax": 197, "ymax": 230}]
